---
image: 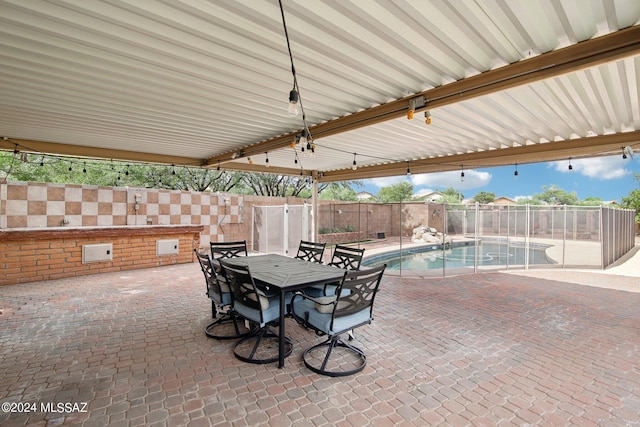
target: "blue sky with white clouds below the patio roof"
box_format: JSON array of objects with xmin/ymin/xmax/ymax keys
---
[{"xmin": 355, "ymin": 155, "xmax": 640, "ymax": 202}]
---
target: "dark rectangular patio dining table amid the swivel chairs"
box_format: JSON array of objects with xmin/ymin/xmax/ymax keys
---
[{"xmin": 219, "ymin": 254, "xmax": 345, "ymax": 368}]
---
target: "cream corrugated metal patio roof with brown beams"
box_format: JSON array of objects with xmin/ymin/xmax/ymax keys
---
[{"xmin": 0, "ymin": 0, "xmax": 640, "ymax": 181}]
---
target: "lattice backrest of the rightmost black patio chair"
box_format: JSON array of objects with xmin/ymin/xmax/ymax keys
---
[{"xmin": 331, "ymin": 264, "xmax": 387, "ymax": 329}]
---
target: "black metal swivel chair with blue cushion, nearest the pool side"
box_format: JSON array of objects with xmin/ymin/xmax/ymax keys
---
[{"xmin": 291, "ymin": 264, "xmax": 386, "ymax": 377}]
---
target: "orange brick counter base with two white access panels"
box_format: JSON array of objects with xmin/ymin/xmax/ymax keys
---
[{"xmin": 0, "ymin": 225, "xmax": 203, "ymax": 285}]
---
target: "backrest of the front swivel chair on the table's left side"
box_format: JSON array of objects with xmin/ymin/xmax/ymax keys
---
[{"xmin": 220, "ymin": 259, "xmax": 269, "ymax": 324}]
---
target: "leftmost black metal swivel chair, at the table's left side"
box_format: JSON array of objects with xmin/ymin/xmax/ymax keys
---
[{"xmin": 193, "ymin": 249, "xmax": 253, "ymax": 340}]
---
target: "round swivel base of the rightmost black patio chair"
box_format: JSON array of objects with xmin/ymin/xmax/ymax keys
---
[{"xmin": 302, "ymin": 335, "xmax": 367, "ymax": 377}]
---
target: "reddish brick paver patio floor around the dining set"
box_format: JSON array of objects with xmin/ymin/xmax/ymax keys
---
[{"xmin": 0, "ymin": 264, "xmax": 640, "ymax": 426}]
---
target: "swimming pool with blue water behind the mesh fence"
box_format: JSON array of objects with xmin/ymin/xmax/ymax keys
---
[{"xmin": 362, "ymin": 241, "xmax": 555, "ymax": 270}]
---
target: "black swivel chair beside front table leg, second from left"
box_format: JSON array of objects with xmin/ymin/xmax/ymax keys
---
[{"xmin": 220, "ymin": 259, "xmax": 293, "ymax": 364}]
